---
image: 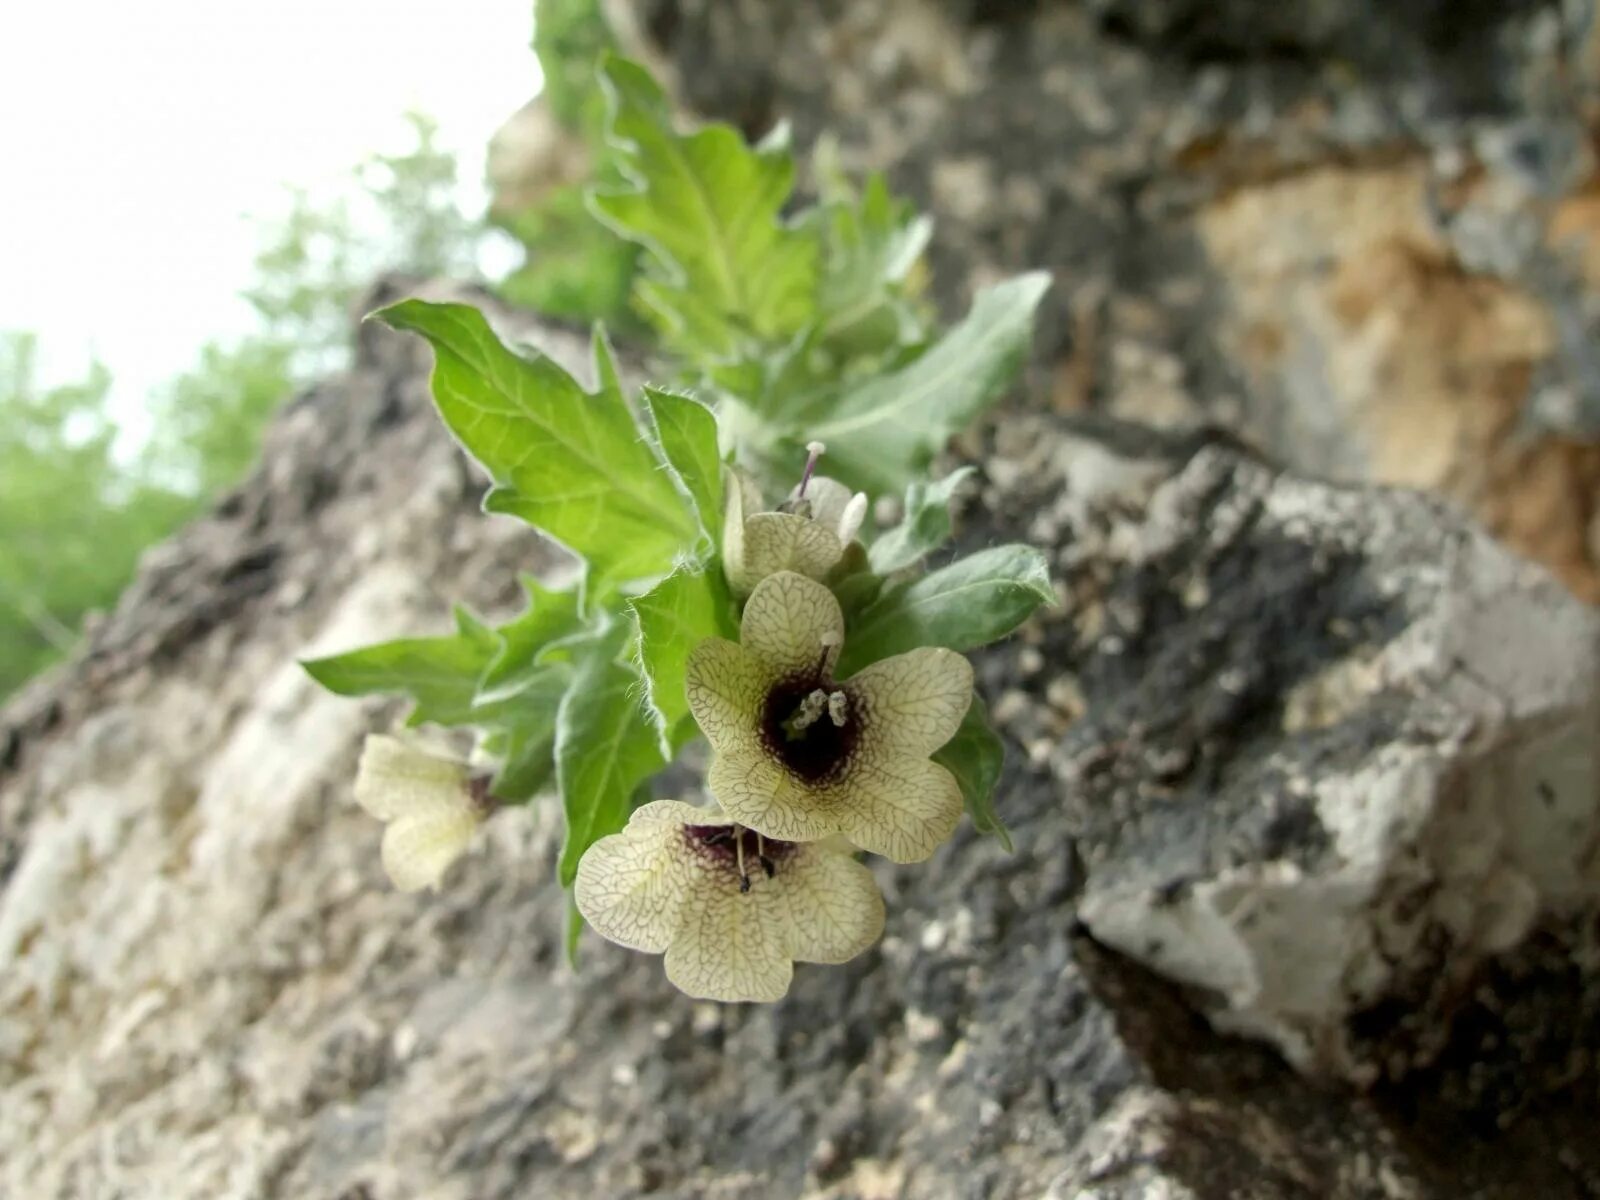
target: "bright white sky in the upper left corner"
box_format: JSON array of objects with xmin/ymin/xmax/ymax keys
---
[{"xmin": 0, "ymin": 0, "xmax": 539, "ymax": 424}]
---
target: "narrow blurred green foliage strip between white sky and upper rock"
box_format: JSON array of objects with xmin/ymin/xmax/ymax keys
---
[{"xmin": 491, "ymin": 0, "xmax": 640, "ymax": 331}]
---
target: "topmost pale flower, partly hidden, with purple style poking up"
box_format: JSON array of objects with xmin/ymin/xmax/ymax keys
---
[{"xmin": 722, "ymin": 467, "xmax": 867, "ymax": 597}]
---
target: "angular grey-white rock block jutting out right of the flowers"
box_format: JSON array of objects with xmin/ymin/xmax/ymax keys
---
[{"xmin": 979, "ymin": 419, "xmax": 1600, "ymax": 1083}]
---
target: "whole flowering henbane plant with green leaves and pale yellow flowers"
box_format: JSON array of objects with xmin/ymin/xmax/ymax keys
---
[{"xmin": 306, "ymin": 59, "xmax": 1053, "ymax": 1000}]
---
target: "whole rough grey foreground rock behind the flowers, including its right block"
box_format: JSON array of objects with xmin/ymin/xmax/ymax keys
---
[{"xmin": 0, "ymin": 284, "xmax": 1600, "ymax": 1200}]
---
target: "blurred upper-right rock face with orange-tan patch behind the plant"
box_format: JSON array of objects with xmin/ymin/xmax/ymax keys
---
[{"xmin": 613, "ymin": 0, "xmax": 1600, "ymax": 600}]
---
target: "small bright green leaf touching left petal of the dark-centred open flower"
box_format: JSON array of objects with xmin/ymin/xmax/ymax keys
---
[{"xmin": 630, "ymin": 560, "xmax": 739, "ymax": 755}]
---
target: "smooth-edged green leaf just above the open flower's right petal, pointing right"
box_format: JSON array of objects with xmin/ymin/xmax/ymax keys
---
[{"xmin": 838, "ymin": 546, "xmax": 1056, "ymax": 675}]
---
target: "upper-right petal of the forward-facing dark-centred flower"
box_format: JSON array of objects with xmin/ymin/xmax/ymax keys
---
[{"xmin": 845, "ymin": 646, "xmax": 973, "ymax": 757}]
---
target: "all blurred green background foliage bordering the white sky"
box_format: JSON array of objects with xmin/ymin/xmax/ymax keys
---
[{"xmin": 0, "ymin": 0, "xmax": 620, "ymax": 698}]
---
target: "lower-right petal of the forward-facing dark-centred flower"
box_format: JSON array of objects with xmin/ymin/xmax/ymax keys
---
[{"xmin": 837, "ymin": 755, "xmax": 962, "ymax": 862}]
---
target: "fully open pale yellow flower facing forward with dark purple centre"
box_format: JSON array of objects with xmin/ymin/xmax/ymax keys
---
[{"xmin": 688, "ymin": 571, "xmax": 973, "ymax": 862}]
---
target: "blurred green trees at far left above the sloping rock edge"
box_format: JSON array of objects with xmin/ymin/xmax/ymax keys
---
[{"xmin": 0, "ymin": 114, "xmax": 482, "ymax": 698}]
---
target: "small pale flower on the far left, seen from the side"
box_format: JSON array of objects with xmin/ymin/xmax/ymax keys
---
[{"xmin": 355, "ymin": 734, "xmax": 490, "ymax": 891}]
